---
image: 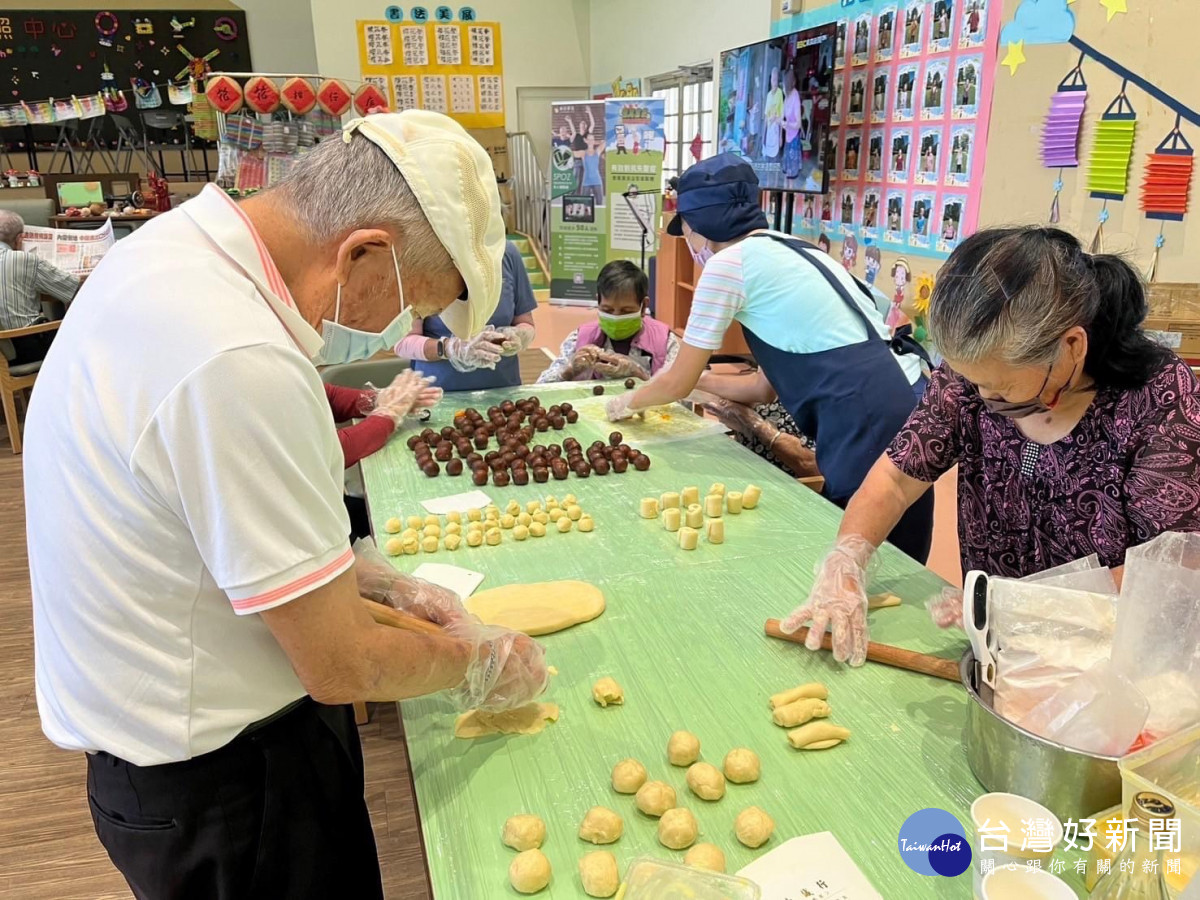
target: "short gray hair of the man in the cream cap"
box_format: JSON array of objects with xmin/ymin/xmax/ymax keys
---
[{"xmin": 270, "ymin": 133, "xmax": 454, "ymax": 271}]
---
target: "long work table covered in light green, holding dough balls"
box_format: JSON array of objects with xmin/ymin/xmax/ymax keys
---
[{"xmin": 362, "ymin": 384, "xmax": 1032, "ymax": 900}]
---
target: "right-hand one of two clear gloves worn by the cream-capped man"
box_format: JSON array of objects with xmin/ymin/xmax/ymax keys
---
[{"xmin": 446, "ymin": 622, "xmax": 548, "ymax": 712}]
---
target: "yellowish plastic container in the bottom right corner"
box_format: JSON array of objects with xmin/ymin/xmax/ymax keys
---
[{"xmin": 1118, "ymin": 725, "xmax": 1200, "ymax": 890}]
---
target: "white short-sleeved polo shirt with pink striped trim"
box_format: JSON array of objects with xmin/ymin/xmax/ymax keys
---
[{"xmin": 25, "ymin": 187, "xmax": 353, "ymax": 766}]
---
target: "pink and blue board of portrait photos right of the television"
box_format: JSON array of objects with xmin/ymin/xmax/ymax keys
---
[{"xmin": 772, "ymin": 0, "xmax": 1001, "ymax": 258}]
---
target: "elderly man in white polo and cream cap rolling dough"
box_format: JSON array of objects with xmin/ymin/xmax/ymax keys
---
[{"xmin": 25, "ymin": 112, "xmax": 546, "ymax": 899}]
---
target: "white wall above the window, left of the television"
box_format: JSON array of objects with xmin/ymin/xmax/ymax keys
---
[{"xmin": 589, "ymin": 0, "xmax": 773, "ymax": 84}]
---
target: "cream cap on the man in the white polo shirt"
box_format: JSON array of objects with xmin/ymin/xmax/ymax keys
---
[{"xmin": 342, "ymin": 109, "xmax": 506, "ymax": 338}]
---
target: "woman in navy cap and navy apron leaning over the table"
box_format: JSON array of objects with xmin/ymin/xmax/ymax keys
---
[{"xmin": 608, "ymin": 154, "xmax": 934, "ymax": 563}]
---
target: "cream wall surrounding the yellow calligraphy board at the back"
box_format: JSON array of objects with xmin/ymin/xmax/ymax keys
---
[{"xmin": 309, "ymin": 0, "xmax": 590, "ymax": 130}]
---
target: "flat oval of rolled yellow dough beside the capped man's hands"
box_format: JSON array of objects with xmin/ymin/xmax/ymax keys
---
[{"xmin": 466, "ymin": 581, "xmax": 604, "ymax": 636}]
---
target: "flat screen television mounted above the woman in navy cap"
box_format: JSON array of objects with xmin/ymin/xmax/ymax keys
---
[{"xmin": 716, "ymin": 23, "xmax": 838, "ymax": 193}]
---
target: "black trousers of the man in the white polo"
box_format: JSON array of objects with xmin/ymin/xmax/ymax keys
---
[{"xmin": 88, "ymin": 698, "xmax": 383, "ymax": 900}]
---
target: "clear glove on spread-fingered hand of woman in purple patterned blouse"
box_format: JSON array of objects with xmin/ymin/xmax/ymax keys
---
[{"xmin": 780, "ymin": 534, "xmax": 875, "ymax": 666}]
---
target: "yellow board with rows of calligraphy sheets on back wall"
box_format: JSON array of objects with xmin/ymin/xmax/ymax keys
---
[{"xmin": 356, "ymin": 19, "xmax": 504, "ymax": 128}]
